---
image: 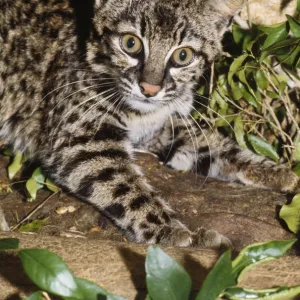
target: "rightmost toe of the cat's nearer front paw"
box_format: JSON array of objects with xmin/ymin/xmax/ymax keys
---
[{"xmin": 193, "ymin": 227, "xmax": 232, "ymax": 250}]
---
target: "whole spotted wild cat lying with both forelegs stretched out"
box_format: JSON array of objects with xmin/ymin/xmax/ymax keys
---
[{"xmin": 0, "ymin": 0, "xmax": 299, "ymax": 248}]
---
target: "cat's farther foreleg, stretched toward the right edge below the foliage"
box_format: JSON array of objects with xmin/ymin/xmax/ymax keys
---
[{"xmin": 146, "ymin": 119, "xmax": 300, "ymax": 193}]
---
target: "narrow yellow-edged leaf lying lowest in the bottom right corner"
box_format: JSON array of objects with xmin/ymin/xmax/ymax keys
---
[{"xmin": 223, "ymin": 286, "xmax": 300, "ymax": 300}]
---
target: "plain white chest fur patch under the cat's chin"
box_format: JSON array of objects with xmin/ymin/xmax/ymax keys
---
[{"xmin": 125, "ymin": 111, "xmax": 169, "ymax": 147}]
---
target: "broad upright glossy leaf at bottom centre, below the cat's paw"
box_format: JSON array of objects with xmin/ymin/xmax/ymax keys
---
[{"xmin": 146, "ymin": 246, "xmax": 192, "ymax": 300}]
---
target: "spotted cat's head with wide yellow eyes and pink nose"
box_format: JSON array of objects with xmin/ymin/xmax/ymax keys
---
[{"xmin": 87, "ymin": 0, "xmax": 244, "ymax": 114}]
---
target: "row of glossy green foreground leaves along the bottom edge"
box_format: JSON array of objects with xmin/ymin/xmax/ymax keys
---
[{"xmin": 0, "ymin": 239, "xmax": 300, "ymax": 300}]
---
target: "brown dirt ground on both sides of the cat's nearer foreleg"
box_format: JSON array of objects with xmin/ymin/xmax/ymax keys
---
[{"xmin": 0, "ymin": 150, "xmax": 293, "ymax": 250}]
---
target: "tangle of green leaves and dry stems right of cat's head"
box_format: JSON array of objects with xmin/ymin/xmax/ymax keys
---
[{"xmin": 194, "ymin": 14, "xmax": 300, "ymax": 172}]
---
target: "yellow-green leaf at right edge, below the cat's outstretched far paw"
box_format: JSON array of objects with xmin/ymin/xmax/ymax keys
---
[{"xmin": 279, "ymin": 194, "xmax": 300, "ymax": 234}]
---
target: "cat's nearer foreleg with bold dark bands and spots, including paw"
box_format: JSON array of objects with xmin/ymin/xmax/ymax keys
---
[{"xmin": 41, "ymin": 124, "xmax": 229, "ymax": 248}]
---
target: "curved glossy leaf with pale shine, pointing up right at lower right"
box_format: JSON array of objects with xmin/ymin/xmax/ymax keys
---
[{"xmin": 232, "ymin": 239, "xmax": 296, "ymax": 278}]
